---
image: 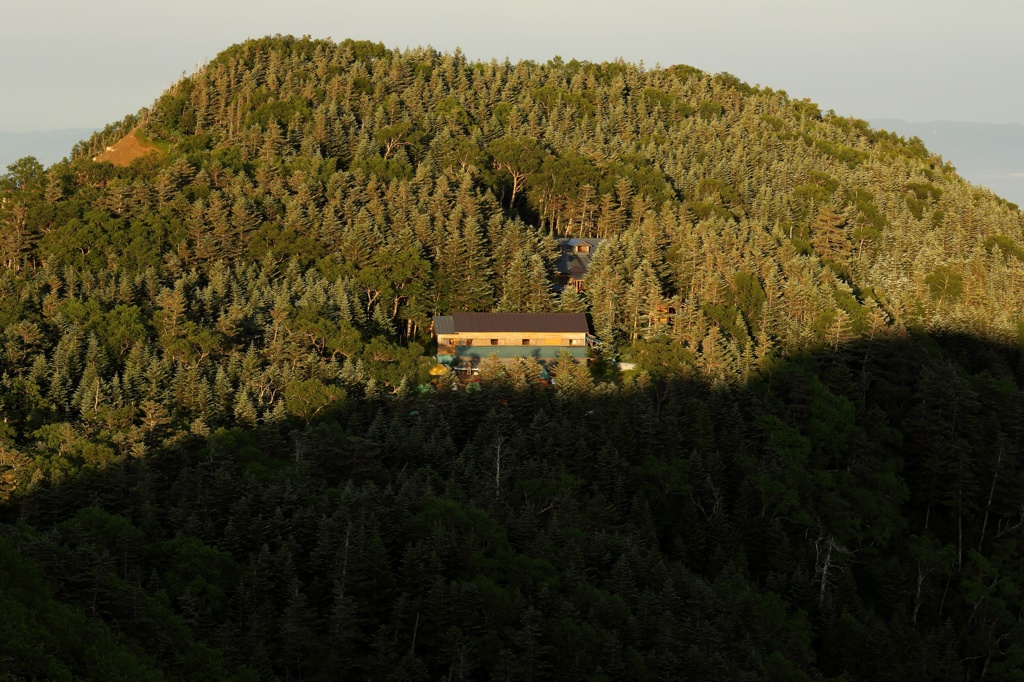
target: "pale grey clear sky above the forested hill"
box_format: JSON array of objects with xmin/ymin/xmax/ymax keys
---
[{"xmin": 0, "ymin": 0, "xmax": 1024, "ymax": 132}]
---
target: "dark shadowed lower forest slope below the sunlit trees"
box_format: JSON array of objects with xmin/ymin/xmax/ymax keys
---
[{"xmin": 0, "ymin": 327, "xmax": 1024, "ymax": 680}]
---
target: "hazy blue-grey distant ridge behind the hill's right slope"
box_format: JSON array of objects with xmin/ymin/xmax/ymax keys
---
[{"xmin": 870, "ymin": 119, "xmax": 1024, "ymax": 206}]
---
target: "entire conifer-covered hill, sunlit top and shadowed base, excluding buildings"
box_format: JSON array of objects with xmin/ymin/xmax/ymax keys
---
[{"xmin": 0, "ymin": 37, "xmax": 1024, "ymax": 680}]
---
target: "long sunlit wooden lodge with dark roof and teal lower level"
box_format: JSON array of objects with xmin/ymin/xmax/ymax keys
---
[{"xmin": 433, "ymin": 312, "xmax": 596, "ymax": 368}]
